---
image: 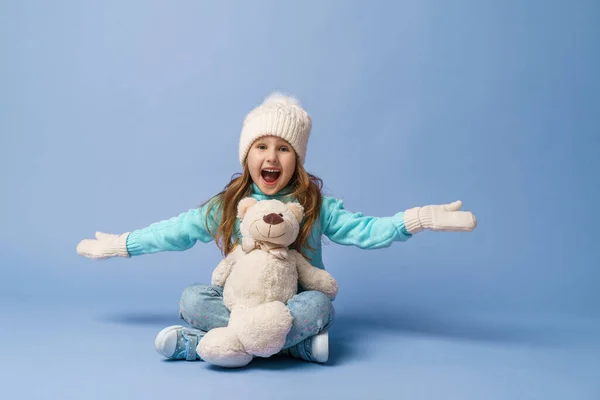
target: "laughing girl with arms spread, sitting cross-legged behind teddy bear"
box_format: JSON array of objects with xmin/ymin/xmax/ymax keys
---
[{"xmin": 77, "ymin": 93, "xmax": 477, "ymax": 363}]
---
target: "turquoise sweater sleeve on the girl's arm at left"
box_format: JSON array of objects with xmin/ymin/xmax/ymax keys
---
[{"xmin": 127, "ymin": 199, "xmax": 219, "ymax": 256}]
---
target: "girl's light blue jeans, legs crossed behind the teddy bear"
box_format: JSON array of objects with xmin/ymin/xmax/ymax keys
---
[{"xmin": 179, "ymin": 284, "xmax": 335, "ymax": 349}]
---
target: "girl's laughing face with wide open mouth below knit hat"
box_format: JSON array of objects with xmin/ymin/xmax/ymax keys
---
[{"xmin": 246, "ymin": 136, "xmax": 296, "ymax": 195}]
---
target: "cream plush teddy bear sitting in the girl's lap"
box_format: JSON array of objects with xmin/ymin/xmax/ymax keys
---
[{"xmin": 196, "ymin": 197, "xmax": 338, "ymax": 368}]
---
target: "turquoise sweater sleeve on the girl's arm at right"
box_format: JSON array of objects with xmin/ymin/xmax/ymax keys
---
[{"xmin": 320, "ymin": 196, "xmax": 412, "ymax": 249}]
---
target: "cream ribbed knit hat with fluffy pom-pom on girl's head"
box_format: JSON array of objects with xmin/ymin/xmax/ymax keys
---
[{"xmin": 239, "ymin": 92, "xmax": 312, "ymax": 166}]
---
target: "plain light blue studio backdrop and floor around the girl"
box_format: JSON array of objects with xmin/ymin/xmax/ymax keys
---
[{"xmin": 0, "ymin": 0, "xmax": 600, "ymax": 400}]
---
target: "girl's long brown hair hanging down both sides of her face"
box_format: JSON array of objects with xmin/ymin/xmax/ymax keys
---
[{"xmin": 202, "ymin": 158, "xmax": 323, "ymax": 261}]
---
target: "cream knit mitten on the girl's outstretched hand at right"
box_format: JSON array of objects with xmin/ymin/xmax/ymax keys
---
[{"xmin": 404, "ymin": 200, "xmax": 477, "ymax": 234}]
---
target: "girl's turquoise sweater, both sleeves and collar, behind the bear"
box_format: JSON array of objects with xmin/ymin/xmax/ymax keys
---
[{"xmin": 127, "ymin": 183, "xmax": 412, "ymax": 269}]
